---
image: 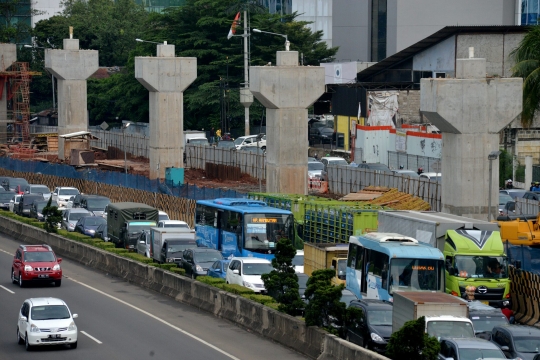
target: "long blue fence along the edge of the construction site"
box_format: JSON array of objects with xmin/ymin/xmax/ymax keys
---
[{"xmin": 0, "ymin": 158, "xmax": 246, "ymax": 200}]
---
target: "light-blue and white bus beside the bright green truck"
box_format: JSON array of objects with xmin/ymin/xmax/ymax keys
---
[{"xmin": 346, "ymin": 232, "xmax": 445, "ymax": 301}]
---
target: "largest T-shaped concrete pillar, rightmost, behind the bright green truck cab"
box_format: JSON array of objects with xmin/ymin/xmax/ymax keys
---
[{"xmin": 420, "ymin": 58, "xmax": 523, "ymax": 220}]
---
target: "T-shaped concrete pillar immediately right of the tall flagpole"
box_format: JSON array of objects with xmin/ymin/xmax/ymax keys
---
[{"xmin": 250, "ymin": 51, "xmax": 324, "ymax": 194}]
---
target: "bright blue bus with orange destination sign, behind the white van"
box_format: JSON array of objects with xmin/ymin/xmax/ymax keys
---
[{"xmin": 195, "ymin": 198, "xmax": 295, "ymax": 260}]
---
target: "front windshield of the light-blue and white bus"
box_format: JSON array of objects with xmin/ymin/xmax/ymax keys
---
[{"xmin": 390, "ymin": 259, "xmax": 444, "ymax": 293}]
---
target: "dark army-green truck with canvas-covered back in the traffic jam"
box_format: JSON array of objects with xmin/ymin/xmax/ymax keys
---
[{"xmin": 107, "ymin": 202, "xmax": 159, "ymax": 250}]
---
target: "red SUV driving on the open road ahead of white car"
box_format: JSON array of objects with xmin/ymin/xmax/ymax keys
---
[{"xmin": 11, "ymin": 245, "xmax": 62, "ymax": 287}]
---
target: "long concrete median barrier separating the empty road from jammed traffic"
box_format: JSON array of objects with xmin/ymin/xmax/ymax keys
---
[{"xmin": 0, "ymin": 216, "xmax": 387, "ymax": 360}]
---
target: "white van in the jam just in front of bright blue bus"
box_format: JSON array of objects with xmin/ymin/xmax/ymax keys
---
[{"xmin": 225, "ymin": 257, "xmax": 273, "ymax": 293}]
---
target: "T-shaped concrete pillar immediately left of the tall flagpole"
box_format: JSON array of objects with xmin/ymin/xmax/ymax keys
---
[{"xmin": 135, "ymin": 44, "xmax": 197, "ymax": 183}]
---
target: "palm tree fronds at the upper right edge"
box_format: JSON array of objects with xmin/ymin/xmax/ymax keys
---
[{"xmin": 510, "ymin": 26, "xmax": 540, "ymax": 128}]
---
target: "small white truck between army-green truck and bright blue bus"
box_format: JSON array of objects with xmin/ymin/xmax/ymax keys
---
[{"xmin": 150, "ymin": 227, "xmax": 197, "ymax": 265}]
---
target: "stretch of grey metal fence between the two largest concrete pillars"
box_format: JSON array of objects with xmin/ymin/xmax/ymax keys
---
[{"xmin": 327, "ymin": 165, "xmax": 441, "ymax": 211}]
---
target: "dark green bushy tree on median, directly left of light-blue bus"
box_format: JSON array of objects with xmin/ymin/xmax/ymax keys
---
[{"xmin": 304, "ymin": 269, "xmax": 346, "ymax": 333}]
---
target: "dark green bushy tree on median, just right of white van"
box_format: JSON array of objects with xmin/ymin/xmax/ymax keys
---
[{"xmin": 261, "ymin": 238, "xmax": 304, "ymax": 316}]
